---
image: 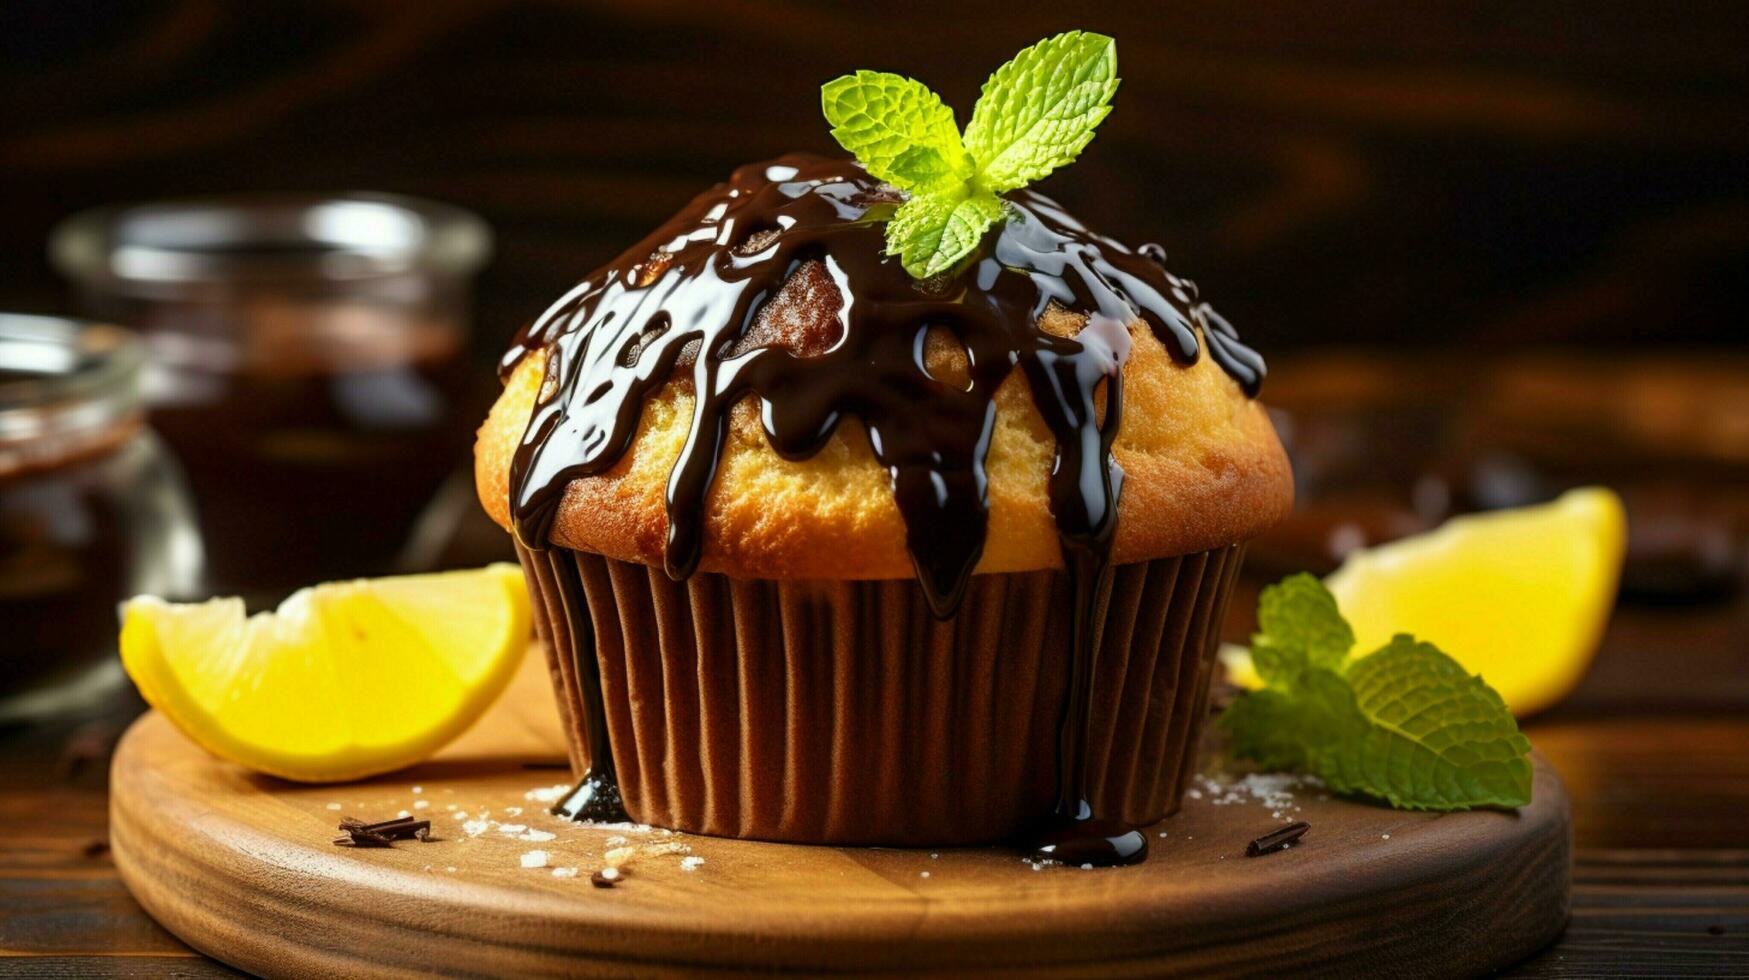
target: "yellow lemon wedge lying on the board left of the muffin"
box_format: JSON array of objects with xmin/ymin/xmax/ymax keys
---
[{"xmin": 121, "ymin": 564, "xmax": 530, "ymax": 782}]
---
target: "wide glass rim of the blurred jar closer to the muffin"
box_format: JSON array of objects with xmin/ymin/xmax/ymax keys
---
[{"xmin": 49, "ymin": 193, "xmax": 491, "ymax": 291}]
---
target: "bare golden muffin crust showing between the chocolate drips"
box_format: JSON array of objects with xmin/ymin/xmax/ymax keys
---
[{"xmin": 474, "ymin": 299, "xmax": 1293, "ymax": 579}]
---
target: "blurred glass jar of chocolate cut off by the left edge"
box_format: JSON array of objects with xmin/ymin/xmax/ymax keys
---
[{"xmin": 0, "ymin": 315, "xmax": 201, "ymax": 721}]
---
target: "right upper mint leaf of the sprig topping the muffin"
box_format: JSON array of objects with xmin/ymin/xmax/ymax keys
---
[{"xmin": 965, "ymin": 32, "xmax": 1118, "ymax": 194}]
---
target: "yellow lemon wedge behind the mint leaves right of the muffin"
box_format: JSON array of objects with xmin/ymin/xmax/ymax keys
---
[{"xmin": 1221, "ymin": 487, "xmax": 1627, "ymax": 718}]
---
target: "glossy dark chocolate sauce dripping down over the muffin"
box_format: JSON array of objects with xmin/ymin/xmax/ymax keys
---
[{"xmin": 504, "ymin": 156, "xmax": 1265, "ymax": 865}]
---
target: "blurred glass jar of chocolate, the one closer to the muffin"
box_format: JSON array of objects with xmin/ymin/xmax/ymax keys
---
[{"xmin": 51, "ymin": 194, "xmax": 490, "ymax": 602}]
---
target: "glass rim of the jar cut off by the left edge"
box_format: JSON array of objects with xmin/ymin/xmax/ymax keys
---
[{"xmin": 0, "ymin": 313, "xmax": 145, "ymax": 471}]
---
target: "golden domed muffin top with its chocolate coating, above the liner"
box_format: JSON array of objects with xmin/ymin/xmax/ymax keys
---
[{"xmin": 476, "ymin": 156, "xmax": 1293, "ymax": 609}]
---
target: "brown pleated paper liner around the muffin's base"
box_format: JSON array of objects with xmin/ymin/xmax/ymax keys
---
[{"xmin": 519, "ymin": 544, "xmax": 1244, "ymax": 845}]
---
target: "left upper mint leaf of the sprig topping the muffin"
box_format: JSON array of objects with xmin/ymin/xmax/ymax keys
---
[{"xmin": 820, "ymin": 72, "xmax": 972, "ymax": 193}]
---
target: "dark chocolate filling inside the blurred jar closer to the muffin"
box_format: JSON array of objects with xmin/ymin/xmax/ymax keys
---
[{"xmin": 145, "ymin": 296, "xmax": 479, "ymax": 595}]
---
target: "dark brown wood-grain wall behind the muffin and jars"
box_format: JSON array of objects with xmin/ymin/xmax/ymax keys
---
[{"xmin": 0, "ymin": 0, "xmax": 1749, "ymax": 354}]
